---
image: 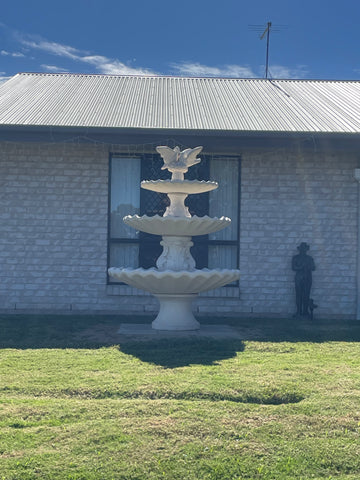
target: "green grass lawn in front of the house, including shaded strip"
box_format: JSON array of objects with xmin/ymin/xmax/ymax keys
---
[{"xmin": 0, "ymin": 316, "xmax": 360, "ymax": 480}]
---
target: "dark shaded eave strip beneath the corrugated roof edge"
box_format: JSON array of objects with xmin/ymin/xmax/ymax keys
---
[{"xmin": 0, "ymin": 125, "xmax": 360, "ymax": 153}]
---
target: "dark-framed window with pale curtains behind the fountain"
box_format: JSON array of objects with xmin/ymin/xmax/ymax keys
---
[{"xmin": 108, "ymin": 154, "xmax": 240, "ymax": 283}]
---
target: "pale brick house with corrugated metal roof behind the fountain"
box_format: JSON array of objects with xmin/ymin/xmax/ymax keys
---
[{"xmin": 0, "ymin": 73, "xmax": 360, "ymax": 319}]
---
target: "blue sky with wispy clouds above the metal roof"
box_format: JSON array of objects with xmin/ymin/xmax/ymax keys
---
[{"xmin": 0, "ymin": 0, "xmax": 360, "ymax": 80}]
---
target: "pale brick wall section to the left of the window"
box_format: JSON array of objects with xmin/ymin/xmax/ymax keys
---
[{"xmin": 0, "ymin": 144, "xmax": 155, "ymax": 312}]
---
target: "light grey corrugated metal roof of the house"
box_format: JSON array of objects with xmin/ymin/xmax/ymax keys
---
[{"xmin": 0, "ymin": 73, "xmax": 360, "ymax": 133}]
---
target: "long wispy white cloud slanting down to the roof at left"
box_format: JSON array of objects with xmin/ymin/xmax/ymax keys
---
[{"xmin": 21, "ymin": 39, "xmax": 156, "ymax": 75}]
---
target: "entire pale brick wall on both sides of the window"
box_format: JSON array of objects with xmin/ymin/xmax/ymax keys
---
[{"xmin": 0, "ymin": 143, "xmax": 358, "ymax": 317}]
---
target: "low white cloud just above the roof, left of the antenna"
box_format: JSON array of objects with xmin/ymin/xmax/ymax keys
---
[{"xmin": 171, "ymin": 62, "xmax": 256, "ymax": 78}]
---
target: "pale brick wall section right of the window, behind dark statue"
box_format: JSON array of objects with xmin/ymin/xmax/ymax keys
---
[{"xmin": 240, "ymin": 151, "xmax": 358, "ymax": 317}]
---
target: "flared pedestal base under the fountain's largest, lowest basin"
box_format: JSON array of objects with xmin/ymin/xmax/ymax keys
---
[{"xmin": 152, "ymin": 294, "xmax": 200, "ymax": 331}]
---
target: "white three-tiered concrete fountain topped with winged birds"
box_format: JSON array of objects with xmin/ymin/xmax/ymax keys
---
[{"xmin": 109, "ymin": 147, "xmax": 240, "ymax": 330}]
